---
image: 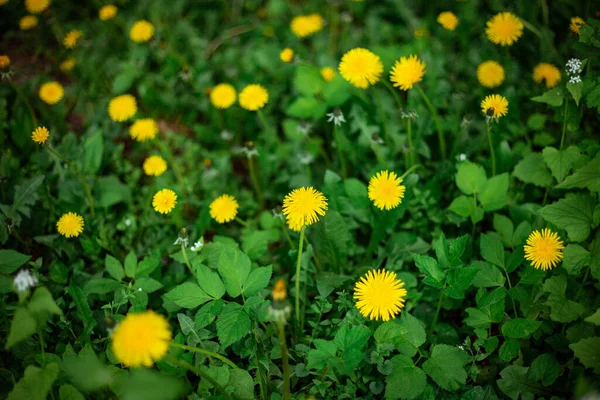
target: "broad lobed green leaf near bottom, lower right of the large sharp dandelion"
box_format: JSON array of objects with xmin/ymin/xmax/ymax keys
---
[{"xmin": 423, "ymin": 344, "xmax": 469, "ymax": 392}]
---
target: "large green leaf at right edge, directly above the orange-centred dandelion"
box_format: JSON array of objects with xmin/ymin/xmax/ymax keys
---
[{"xmin": 538, "ymin": 193, "xmax": 596, "ymax": 242}]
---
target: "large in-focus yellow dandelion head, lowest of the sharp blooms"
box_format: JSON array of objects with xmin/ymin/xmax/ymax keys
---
[{"xmin": 354, "ymin": 270, "xmax": 407, "ymax": 321}]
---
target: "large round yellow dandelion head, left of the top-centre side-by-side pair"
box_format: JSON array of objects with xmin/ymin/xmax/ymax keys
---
[{"xmin": 338, "ymin": 47, "xmax": 383, "ymax": 89}]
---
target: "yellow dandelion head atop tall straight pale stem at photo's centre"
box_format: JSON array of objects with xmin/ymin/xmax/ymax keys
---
[{"xmin": 283, "ymin": 187, "xmax": 327, "ymax": 232}]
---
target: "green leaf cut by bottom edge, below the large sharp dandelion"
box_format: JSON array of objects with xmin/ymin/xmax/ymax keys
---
[{"xmin": 385, "ymin": 355, "xmax": 427, "ymax": 400}]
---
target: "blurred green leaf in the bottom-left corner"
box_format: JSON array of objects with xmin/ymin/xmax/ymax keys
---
[{"xmin": 7, "ymin": 363, "xmax": 60, "ymax": 400}]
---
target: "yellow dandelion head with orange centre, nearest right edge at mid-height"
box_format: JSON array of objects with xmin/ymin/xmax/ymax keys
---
[{"xmin": 525, "ymin": 228, "xmax": 565, "ymax": 271}]
